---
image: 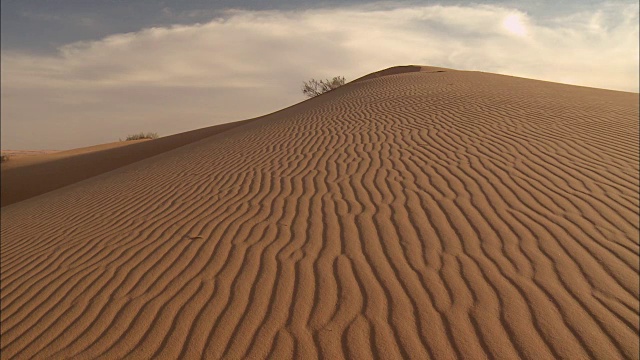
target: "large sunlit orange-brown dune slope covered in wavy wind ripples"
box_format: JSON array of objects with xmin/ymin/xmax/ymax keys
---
[{"xmin": 0, "ymin": 67, "xmax": 639, "ymax": 359}]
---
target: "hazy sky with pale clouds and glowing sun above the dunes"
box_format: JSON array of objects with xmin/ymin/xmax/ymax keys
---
[{"xmin": 0, "ymin": 0, "xmax": 639, "ymax": 150}]
